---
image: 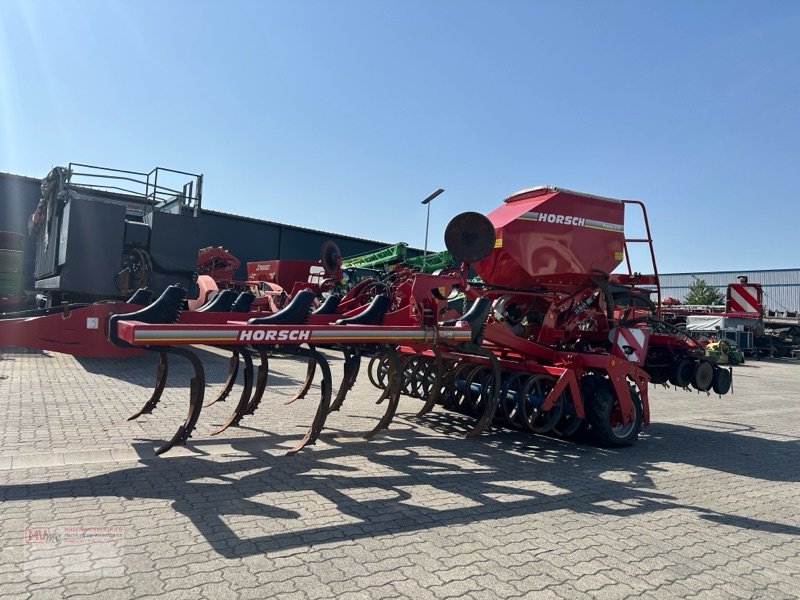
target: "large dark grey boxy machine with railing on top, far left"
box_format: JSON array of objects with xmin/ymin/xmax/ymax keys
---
[{"xmin": 28, "ymin": 163, "xmax": 203, "ymax": 307}]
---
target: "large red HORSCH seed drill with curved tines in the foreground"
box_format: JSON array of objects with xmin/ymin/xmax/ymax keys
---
[{"xmin": 98, "ymin": 187, "xmax": 732, "ymax": 453}]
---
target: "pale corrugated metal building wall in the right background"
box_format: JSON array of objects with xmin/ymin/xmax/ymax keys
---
[{"xmin": 661, "ymin": 269, "xmax": 800, "ymax": 311}]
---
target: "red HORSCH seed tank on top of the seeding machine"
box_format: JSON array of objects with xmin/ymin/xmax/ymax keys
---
[{"xmin": 472, "ymin": 187, "xmax": 625, "ymax": 288}]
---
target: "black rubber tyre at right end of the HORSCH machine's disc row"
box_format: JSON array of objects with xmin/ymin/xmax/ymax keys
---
[{"xmin": 581, "ymin": 376, "xmax": 643, "ymax": 448}]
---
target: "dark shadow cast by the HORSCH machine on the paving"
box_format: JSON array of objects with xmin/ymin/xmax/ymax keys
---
[{"xmin": 0, "ymin": 412, "xmax": 800, "ymax": 558}]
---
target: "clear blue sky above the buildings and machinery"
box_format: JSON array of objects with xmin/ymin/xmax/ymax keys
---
[{"xmin": 0, "ymin": 0, "xmax": 800, "ymax": 272}]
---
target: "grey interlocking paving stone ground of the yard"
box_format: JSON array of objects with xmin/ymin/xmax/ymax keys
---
[{"xmin": 0, "ymin": 350, "xmax": 800, "ymax": 600}]
